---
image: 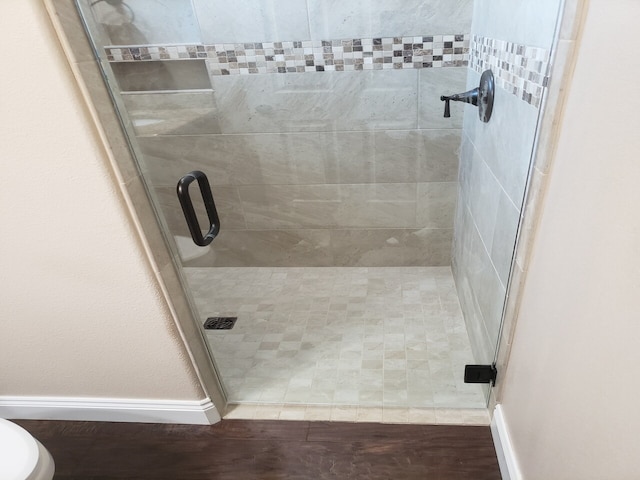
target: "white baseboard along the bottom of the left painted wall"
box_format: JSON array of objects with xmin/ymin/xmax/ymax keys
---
[{"xmin": 0, "ymin": 396, "xmax": 220, "ymax": 425}]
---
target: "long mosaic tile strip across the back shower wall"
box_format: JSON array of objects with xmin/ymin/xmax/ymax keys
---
[{"xmin": 105, "ymin": 34, "xmax": 470, "ymax": 75}]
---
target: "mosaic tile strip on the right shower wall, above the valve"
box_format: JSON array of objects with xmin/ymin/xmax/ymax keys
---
[{"xmin": 469, "ymin": 35, "xmax": 549, "ymax": 108}]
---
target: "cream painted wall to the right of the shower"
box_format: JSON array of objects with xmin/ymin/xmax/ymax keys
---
[{"xmin": 501, "ymin": 0, "xmax": 640, "ymax": 480}]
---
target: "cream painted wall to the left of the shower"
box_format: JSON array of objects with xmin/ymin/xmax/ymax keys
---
[{"xmin": 0, "ymin": 0, "xmax": 205, "ymax": 400}]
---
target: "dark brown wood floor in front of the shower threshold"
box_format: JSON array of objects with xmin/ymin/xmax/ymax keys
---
[{"xmin": 13, "ymin": 420, "xmax": 500, "ymax": 480}]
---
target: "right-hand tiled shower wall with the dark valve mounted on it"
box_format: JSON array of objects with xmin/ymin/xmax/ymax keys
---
[{"xmin": 453, "ymin": 0, "xmax": 561, "ymax": 363}]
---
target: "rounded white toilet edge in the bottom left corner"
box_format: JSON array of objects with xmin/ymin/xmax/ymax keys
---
[{"xmin": 0, "ymin": 418, "xmax": 54, "ymax": 480}]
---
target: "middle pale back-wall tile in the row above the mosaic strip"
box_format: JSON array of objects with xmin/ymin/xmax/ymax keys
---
[{"xmin": 194, "ymin": 0, "xmax": 309, "ymax": 43}]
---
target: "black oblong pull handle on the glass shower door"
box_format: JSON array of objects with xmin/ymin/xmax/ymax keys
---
[{"xmin": 177, "ymin": 170, "xmax": 220, "ymax": 247}]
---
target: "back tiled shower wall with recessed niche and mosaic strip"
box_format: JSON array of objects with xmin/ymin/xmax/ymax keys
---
[{"xmin": 86, "ymin": 0, "xmax": 472, "ymax": 267}]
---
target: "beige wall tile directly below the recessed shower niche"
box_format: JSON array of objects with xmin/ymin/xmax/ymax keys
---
[{"xmin": 122, "ymin": 91, "xmax": 220, "ymax": 135}]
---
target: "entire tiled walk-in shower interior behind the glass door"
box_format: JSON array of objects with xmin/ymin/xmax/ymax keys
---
[{"xmin": 77, "ymin": 0, "xmax": 559, "ymax": 418}]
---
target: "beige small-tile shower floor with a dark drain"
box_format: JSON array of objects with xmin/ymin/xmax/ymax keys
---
[{"xmin": 185, "ymin": 267, "xmax": 486, "ymax": 418}]
